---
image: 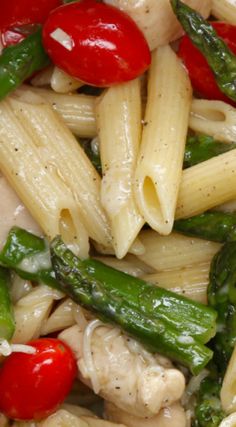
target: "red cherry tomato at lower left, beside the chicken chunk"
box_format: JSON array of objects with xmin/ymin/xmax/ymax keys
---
[{"xmin": 0, "ymin": 338, "xmax": 76, "ymax": 420}]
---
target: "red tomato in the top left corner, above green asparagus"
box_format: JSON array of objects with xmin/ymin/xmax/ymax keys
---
[{"xmin": 0, "ymin": 0, "xmax": 62, "ymax": 47}]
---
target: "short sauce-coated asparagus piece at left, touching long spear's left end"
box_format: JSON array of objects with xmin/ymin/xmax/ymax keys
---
[{"xmin": 0, "ymin": 227, "xmax": 57, "ymax": 288}]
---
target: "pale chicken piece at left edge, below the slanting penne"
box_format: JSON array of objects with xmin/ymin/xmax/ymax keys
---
[{"xmin": 0, "ymin": 174, "xmax": 41, "ymax": 248}]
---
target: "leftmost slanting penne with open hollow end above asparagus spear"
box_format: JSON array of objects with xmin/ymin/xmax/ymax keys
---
[{"xmin": 0, "ymin": 98, "xmax": 89, "ymax": 257}]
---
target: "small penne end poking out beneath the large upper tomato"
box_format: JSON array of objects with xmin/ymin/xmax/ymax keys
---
[{"xmin": 50, "ymin": 67, "xmax": 84, "ymax": 93}]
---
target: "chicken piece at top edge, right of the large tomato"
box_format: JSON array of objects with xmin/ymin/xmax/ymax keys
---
[{"xmin": 105, "ymin": 0, "xmax": 211, "ymax": 50}]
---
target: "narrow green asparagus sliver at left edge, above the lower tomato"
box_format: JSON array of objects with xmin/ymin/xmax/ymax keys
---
[{"xmin": 0, "ymin": 268, "xmax": 15, "ymax": 340}]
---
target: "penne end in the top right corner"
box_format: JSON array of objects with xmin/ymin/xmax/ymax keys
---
[{"xmin": 211, "ymin": 0, "xmax": 236, "ymax": 25}]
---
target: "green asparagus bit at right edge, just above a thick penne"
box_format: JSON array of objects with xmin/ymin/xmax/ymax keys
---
[{"xmin": 184, "ymin": 135, "xmax": 236, "ymax": 168}]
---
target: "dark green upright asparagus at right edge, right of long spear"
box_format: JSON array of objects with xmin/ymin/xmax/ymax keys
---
[{"xmin": 208, "ymin": 242, "xmax": 236, "ymax": 372}]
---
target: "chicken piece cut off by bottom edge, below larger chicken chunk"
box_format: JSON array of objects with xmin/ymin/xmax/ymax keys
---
[{"xmin": 105, "ymin": 402, "xmax": 187, "ymax": 427}]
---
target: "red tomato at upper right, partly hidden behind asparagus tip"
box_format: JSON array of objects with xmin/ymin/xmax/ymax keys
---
[{"xmin": 178, "ymin": 22, "xmax": 236, "ymax": 103}]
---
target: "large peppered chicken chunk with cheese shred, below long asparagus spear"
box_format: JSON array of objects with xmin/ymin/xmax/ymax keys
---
[{"xmin": 59, "ymin": 320, "xmax": 185, "ymax": 417}]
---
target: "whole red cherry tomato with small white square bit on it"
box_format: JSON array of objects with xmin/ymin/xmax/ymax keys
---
[{"xmin": 43, "ymin": 0, "xmax": 151, "ymax": 86}]
